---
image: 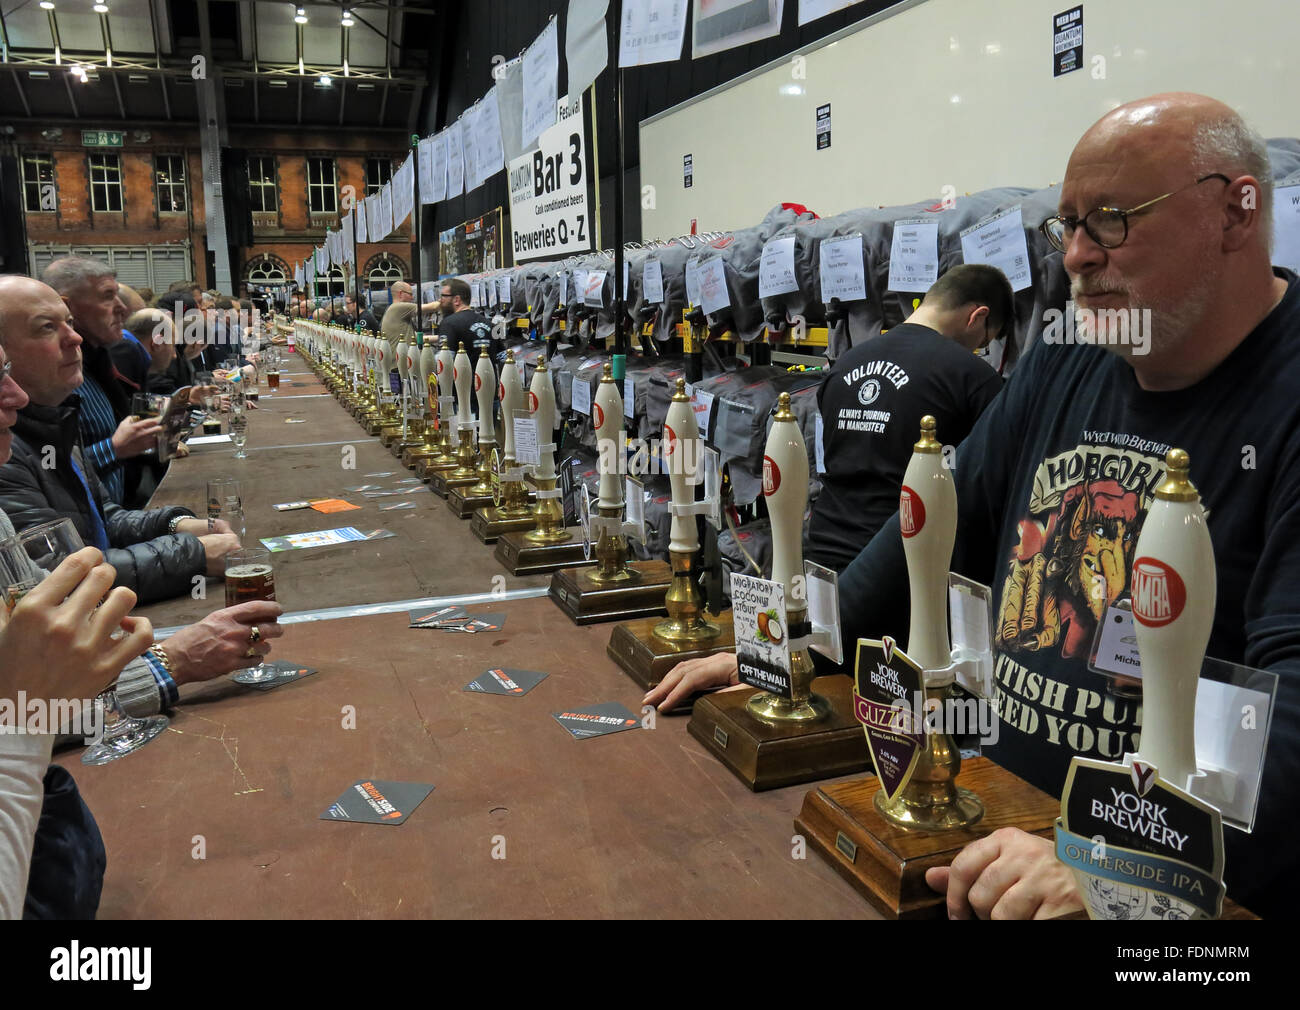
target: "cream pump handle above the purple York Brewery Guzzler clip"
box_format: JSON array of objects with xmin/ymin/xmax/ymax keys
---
[{"xmin": 898, "ymin": 415, "xmax": 957, "ymax": 686}]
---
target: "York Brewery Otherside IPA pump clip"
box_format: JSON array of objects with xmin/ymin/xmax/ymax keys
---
[{"xmin": 1056, "ymin": 758, "xmax": 1223, "ymax": 920}]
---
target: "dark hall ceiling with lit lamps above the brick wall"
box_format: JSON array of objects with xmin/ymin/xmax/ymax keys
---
[{"xmin": 0, "ymin": 0, "xmax": 447, "ymax": 131}]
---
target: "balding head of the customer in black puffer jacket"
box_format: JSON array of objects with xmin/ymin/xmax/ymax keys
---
[{"xmin": 0, "ymin": 274, "xmax": 82, "ymax": 407}]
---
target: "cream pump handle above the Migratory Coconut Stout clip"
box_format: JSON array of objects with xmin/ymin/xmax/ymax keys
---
[{"xmin": 763, "ymin": 393, "xmax": 809, "ymax": 610}]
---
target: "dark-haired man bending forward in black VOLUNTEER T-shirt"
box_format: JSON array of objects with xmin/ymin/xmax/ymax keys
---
[{"xmin": 805, "ymin": 264, "xmax": 1015, "ymax": 572}]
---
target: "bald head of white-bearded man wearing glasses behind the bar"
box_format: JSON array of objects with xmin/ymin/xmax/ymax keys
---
[{"xmin": 1060, "ymin": 92, "xmax": 1286, "ymax": 389}]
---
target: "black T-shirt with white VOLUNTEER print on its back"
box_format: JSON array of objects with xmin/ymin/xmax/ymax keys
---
[{"xmin": 806, "ymin": 322, "xmax": 1002, "ymax": 572}]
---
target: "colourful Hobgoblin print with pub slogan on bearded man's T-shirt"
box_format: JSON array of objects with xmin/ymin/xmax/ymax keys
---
[{"xmin": 989, "ymin": 430, "xmax": 1191, "ymax": 764}]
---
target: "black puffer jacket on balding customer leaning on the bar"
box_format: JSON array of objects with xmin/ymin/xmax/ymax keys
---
[{"xmin": 0, "ymin": 394, "xmax": 207, "ymax": 606}]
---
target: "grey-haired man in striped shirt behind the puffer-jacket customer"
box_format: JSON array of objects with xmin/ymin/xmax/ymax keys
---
[{"xmin": 42, "ymin": 256, "xmax": 163, "ymax": 504}]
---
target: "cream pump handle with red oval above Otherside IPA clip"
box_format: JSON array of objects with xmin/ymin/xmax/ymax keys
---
[{"xmin": 1131, "ymin": 448, "xmax": 1216, "ymax": 789}]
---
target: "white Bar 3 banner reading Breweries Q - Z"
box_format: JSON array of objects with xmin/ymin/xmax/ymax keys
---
[{"xmin": 508, "ymin": 97, "xmax": 594, "ymax": 263}]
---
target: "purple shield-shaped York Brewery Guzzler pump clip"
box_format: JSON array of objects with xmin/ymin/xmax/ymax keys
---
[{"xmin": 853, "ymin": 636, "xmax": 926, "ymax": 801}]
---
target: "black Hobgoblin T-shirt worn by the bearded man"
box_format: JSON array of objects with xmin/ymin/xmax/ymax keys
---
[{"xmin": 840, "ymin": 270, "xmax": 1300, "ymax": 916}]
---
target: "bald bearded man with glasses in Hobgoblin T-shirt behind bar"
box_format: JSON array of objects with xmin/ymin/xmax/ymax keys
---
[{"xmin": 647, "ymin": 94, "xmax": 1300, "ymax": 918}]
